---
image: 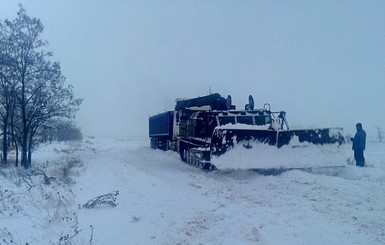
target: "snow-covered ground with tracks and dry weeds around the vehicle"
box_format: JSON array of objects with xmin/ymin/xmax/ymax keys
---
[{"xmin": 0, "ymin": 138, "xmax": 385, "ymax": 245}]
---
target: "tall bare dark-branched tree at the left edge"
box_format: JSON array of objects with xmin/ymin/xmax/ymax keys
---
[{"xmin": 2, "ymin": 5, "xmax": 82, "ymax": 168}]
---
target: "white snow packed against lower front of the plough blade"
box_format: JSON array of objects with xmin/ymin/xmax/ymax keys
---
[{"xmin": 212, "ymin": 142, "xmax": 350, "ymax": 170}]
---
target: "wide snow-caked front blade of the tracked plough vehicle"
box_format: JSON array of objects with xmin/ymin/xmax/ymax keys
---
[{"xmin": 210, "ymin": 128, "xmax": 346, "ymax": 169}]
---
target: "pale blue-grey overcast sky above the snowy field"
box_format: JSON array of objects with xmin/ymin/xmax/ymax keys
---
[{"xmin": 0, "ymin": 0, "xmax": 385, "ymax": 138}]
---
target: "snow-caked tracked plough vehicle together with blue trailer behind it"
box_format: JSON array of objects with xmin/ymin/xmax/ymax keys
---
[{"xmin": 149, "ymin": 93, "xmax": 345, "ymax": 170}]
